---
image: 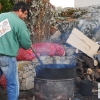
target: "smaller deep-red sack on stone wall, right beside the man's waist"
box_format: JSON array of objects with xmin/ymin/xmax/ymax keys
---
[{"xmin": 16, "ymin": 48, "xmax": 39, "ymax": 61}]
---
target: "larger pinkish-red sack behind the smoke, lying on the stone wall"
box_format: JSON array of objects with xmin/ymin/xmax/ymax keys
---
[{"xmin": 33, "ymin": 42, "xmax": 65, "ymax": 56}]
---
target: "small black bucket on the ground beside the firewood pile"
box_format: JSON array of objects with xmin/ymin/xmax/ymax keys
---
[{"xmin": 80, "ymin": 80, "xmax": 93, "ymax": 96}]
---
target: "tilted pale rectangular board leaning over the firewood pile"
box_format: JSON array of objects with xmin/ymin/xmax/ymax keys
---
[{"xmin": 66, "ymin": 28, "xmax": 100, "ymax": 66}]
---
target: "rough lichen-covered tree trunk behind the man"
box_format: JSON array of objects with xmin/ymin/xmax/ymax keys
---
[{"xmin": 27, "ymin": 0, "xmax": 54, "ymax": 43}]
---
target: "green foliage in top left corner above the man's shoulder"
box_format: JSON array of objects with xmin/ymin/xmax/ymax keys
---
[{"xmin": 0, "ymin": 0, "xmax": 13, "ymax": 13}]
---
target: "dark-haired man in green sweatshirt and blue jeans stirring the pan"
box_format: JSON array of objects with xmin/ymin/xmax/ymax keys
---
[{"xmin": 0, "ymin": 1, "xmax": 31, "ymax": 100}]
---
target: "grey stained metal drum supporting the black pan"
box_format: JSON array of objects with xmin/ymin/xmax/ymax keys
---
[{"xmin": 34, "ymin": 78, "xmax": 74, "ymax": 100}]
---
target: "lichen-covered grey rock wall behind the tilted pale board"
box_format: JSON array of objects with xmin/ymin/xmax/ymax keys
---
[{"xmin": 52, "ymin": 5, "xmax": 100, "ymax": 42}]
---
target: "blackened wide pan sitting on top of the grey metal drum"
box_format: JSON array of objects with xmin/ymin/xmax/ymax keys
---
[{"xmin": 35, "ymin": 64, "xmax": 76, "ymax": 80}]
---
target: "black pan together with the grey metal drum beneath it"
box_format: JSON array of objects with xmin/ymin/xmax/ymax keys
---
[{"xmin": 34, "ymin": 64, "xmax": 76, "ymax": 100}]
